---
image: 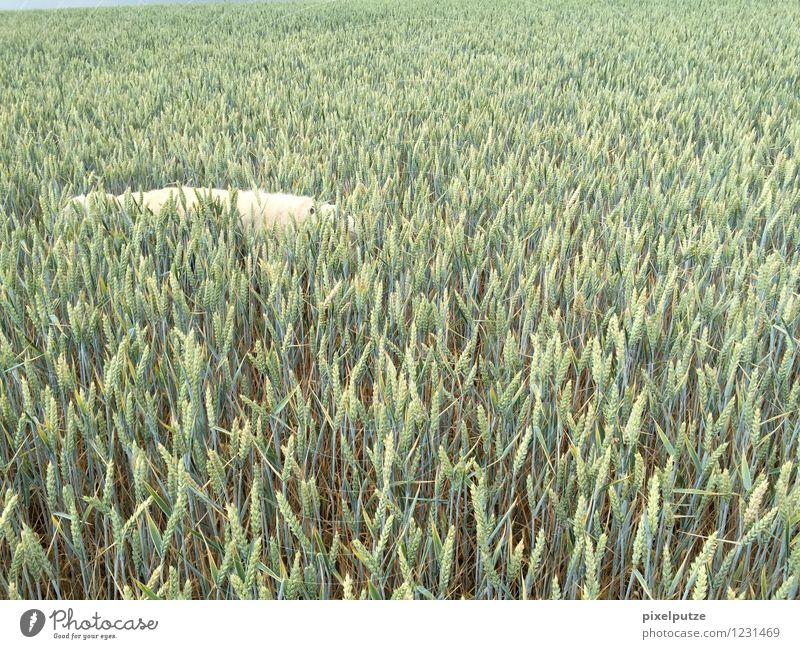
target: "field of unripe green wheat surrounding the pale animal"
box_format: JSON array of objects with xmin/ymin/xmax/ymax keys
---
[{"xmin": 0, "ymin": 0, "xmax": 800, "ymax": 599}]
